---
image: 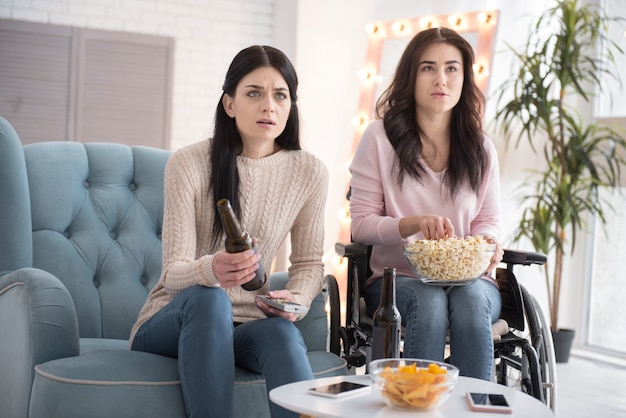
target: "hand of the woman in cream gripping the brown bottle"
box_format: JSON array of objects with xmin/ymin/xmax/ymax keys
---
[{"xmin": 212, "ymin": 250, "xmax": 261, "ymax": 289}]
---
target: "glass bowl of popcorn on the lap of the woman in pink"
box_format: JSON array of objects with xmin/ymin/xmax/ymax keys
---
[{"xmin": 404, "ymin": 235, "xmax": 496, "ymax": 286}]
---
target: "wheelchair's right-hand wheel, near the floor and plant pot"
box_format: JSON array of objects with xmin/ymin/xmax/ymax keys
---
[{"xmin": 495, "ymin": 286, "xmax": 556, "ymax": 411}]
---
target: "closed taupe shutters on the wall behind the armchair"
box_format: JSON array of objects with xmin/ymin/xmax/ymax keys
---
[{"xmin": 0, "ymin": 20, "xmax": 174, "ymax": 148}]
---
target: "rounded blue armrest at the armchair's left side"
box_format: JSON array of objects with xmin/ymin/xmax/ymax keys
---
[{"xmin": 0, "ymin": 268, "xmax": 79, "ymax": 416}]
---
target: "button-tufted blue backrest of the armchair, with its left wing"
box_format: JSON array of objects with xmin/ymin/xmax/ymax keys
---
[{"xmin": 0, "ymin": 118, "xmax": 170, "ymax": 339}]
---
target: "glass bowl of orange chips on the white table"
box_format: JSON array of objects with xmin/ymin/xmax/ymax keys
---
[{"xmin": 369, "ymin": 358, "xmax": 459, "ymax": 411}]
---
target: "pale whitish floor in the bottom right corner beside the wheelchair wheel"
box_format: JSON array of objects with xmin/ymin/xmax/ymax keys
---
[{"xmin": 556, "ymin": 355, "xmax": 626, "ymax": 418}]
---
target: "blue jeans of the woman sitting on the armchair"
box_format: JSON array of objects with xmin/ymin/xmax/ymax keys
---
[{"xmin": 132, "ymin": 286, "xmax": 313, "ymax": 418}]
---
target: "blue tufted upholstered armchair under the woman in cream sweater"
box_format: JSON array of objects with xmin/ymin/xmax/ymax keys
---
[{"xmin": 0, "ymin": 117, "xmax": 347, "ymax": 418}]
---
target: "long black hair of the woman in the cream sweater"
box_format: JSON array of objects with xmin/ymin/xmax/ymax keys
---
[{"xmin": 209, "ymin": 45, "xmax": 301, "ymax": 243}]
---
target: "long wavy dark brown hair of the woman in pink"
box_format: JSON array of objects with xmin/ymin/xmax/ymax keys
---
[{"xmin": 376, "ymin": 28, "xmax": 487, "ymax": 198}]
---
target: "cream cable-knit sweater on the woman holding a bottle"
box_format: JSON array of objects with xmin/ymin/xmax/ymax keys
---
[{"xmin": 130, "ymin": 140, "xmax": 328, "ymax": 342}]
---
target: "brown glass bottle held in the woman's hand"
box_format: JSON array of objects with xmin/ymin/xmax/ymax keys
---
[{"xmin": 217, "ymin": 199, "xmax": 267, "ymax": 291}]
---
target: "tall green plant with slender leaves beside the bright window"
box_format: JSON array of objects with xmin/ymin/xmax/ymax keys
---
[{"xmin": 495, "ymin": 0, "xmax": 626, "ymax": 362}]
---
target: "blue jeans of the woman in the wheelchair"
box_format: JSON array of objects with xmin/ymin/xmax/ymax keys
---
[{"xmin": 365, "ymin": 276, "xmax": 502, "ymax": 380}]
